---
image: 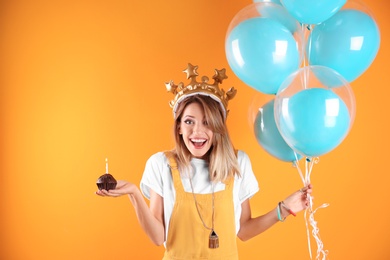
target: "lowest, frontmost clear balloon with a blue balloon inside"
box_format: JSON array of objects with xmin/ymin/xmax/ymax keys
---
[{"xmin": 274, "ymin": 66, "xmax": 355, "ymax": 157}]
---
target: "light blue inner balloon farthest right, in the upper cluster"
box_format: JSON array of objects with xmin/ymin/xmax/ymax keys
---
[{"xmin": 307, "ymin": 9, "xmax": 380, "ymax": 82}]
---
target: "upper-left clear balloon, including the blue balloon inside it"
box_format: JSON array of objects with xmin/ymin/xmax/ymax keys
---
[{"xmin": 225, "ymin": 2, "xmax": 303, "ymax": 94}]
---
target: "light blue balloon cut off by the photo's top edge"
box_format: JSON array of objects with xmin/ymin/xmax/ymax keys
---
[{"xmin": 281, "ymin": 0, "xmax": 347, "ymax": 24}]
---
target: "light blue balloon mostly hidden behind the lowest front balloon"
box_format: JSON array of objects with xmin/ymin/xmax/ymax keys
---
[{"xmin": 254, "ymin": 99, "xmax": 302, "ymax": 162}]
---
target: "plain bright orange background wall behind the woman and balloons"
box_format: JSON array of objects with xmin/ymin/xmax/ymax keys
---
[{"xmin": 0, "ymin": 0, "xmax": 390, "ymax": 260}]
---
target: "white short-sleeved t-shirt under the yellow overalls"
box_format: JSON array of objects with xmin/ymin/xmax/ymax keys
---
[{"xmin": 140, "ymin": 151, "xmax": 259, "ymax": 243}]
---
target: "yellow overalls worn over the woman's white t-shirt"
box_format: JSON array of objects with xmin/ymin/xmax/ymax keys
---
[{"xmin": 163, "ymin": 153, "xmax": 238, "ymax": 260}]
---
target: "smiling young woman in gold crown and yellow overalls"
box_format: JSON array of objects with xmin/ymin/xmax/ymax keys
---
[{"xmin": 96, "ymin": 64, "xmax": 312, "ymax": 260}]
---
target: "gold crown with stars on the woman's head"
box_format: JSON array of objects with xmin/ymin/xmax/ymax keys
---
[{"xmin": 165, "ymin": 63, "xmax": 237, "ymax": 119}]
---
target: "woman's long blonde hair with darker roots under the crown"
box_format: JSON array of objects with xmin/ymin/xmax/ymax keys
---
[{"xmin": 173, "ymin": 95, "xmax": 240, "ymax": 182}]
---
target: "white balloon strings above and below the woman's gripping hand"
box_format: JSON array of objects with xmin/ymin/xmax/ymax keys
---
[{"xmin": 294, "ymin": 153, "xmax": 329, "ymax": 260}]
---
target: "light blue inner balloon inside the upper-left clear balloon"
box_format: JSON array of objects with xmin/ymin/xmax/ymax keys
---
[{"xmin": 225, "ymin": 17, "xmax": 299, "ymax": 94}]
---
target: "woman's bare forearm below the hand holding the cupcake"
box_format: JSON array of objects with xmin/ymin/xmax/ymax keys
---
[{"xmin": 129, "ymin": 189, "xmax": 165, "ymax": 246}]
